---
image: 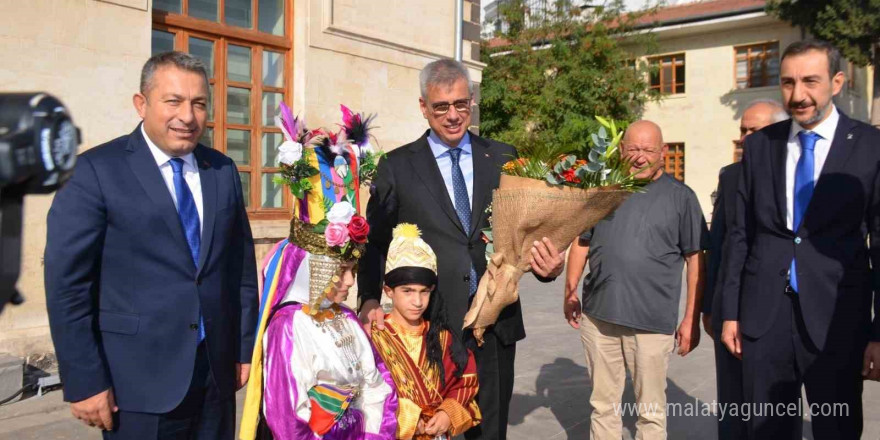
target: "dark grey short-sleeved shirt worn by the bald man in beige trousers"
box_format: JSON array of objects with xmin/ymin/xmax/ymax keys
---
[{"xmin": 581, "ymin": 173, "xmax": 708, "ymax": 334}]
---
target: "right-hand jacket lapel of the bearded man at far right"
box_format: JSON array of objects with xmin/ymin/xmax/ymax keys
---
[{"xmin": 804, "ymin": 113, "xmax": 858, "ymax": 231}]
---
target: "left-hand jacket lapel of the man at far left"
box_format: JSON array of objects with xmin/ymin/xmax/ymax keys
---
[{"xmin": 126, "ymin": 125, "xmax": 192, "ymax": 261}]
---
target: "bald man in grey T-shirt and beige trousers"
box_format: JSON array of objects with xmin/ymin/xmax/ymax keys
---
[{"xmin": 564, "ymin": 121, "xmax": 708, "ymax": 440}]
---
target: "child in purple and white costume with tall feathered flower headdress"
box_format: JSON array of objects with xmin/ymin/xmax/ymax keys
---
[{"xmin": 239, "ymin": 104, "xmax": 397, "ymax": 440}]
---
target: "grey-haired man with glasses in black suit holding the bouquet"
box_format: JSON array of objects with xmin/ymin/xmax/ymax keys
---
[{"xmin": 358, "ymin": 59, "xmax": 564, "ymax": 440}]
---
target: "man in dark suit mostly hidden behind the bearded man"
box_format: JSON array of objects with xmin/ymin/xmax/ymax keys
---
[{"xmin": 702, "ymin": 99, "xmax": 788, "ymax": 440}]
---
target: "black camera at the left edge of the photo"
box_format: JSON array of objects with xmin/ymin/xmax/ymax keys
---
[{"xmin": 0, "ymin": 93, "xmax": 80, "ymax": 312}]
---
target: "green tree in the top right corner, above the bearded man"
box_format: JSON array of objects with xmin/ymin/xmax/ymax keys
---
[{"xmin": 767, "ymin": 0, "xmax": 880, "ymax": 126}]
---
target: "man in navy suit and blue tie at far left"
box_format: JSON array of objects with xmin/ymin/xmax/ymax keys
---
[{"xmin": 45, "ymin": 52, "xmax": 257, "ymax": 440}]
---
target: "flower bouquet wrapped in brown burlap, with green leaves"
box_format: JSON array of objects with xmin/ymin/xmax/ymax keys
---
[{"xmin": 464, "ymin": 117, "xmax": 646, "ymax": 345}]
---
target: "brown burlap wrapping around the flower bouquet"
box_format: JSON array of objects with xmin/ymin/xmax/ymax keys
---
[{"xmin": 464, "ymin": 175, "xmax": 630, "ymax": 345}]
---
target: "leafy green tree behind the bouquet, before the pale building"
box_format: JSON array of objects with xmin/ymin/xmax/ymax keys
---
[{"xmin": 480, "ymin": 0, "xmax": 653, "ymax": 155}]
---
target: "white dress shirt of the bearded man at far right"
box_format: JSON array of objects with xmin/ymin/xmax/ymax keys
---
[{"xmin": 785, "ymin": 104, "xmax": 840, "ymax": 231}]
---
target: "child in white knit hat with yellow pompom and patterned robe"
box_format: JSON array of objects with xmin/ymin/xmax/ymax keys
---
[{"xmin": 371, "ymin": 223, "xmax": 480, "ymax": 440}]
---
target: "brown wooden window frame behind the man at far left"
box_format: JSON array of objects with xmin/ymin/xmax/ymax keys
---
[{"xmin": 152, "ymin": 0, "xmax": 293, "ymax": 220}]
